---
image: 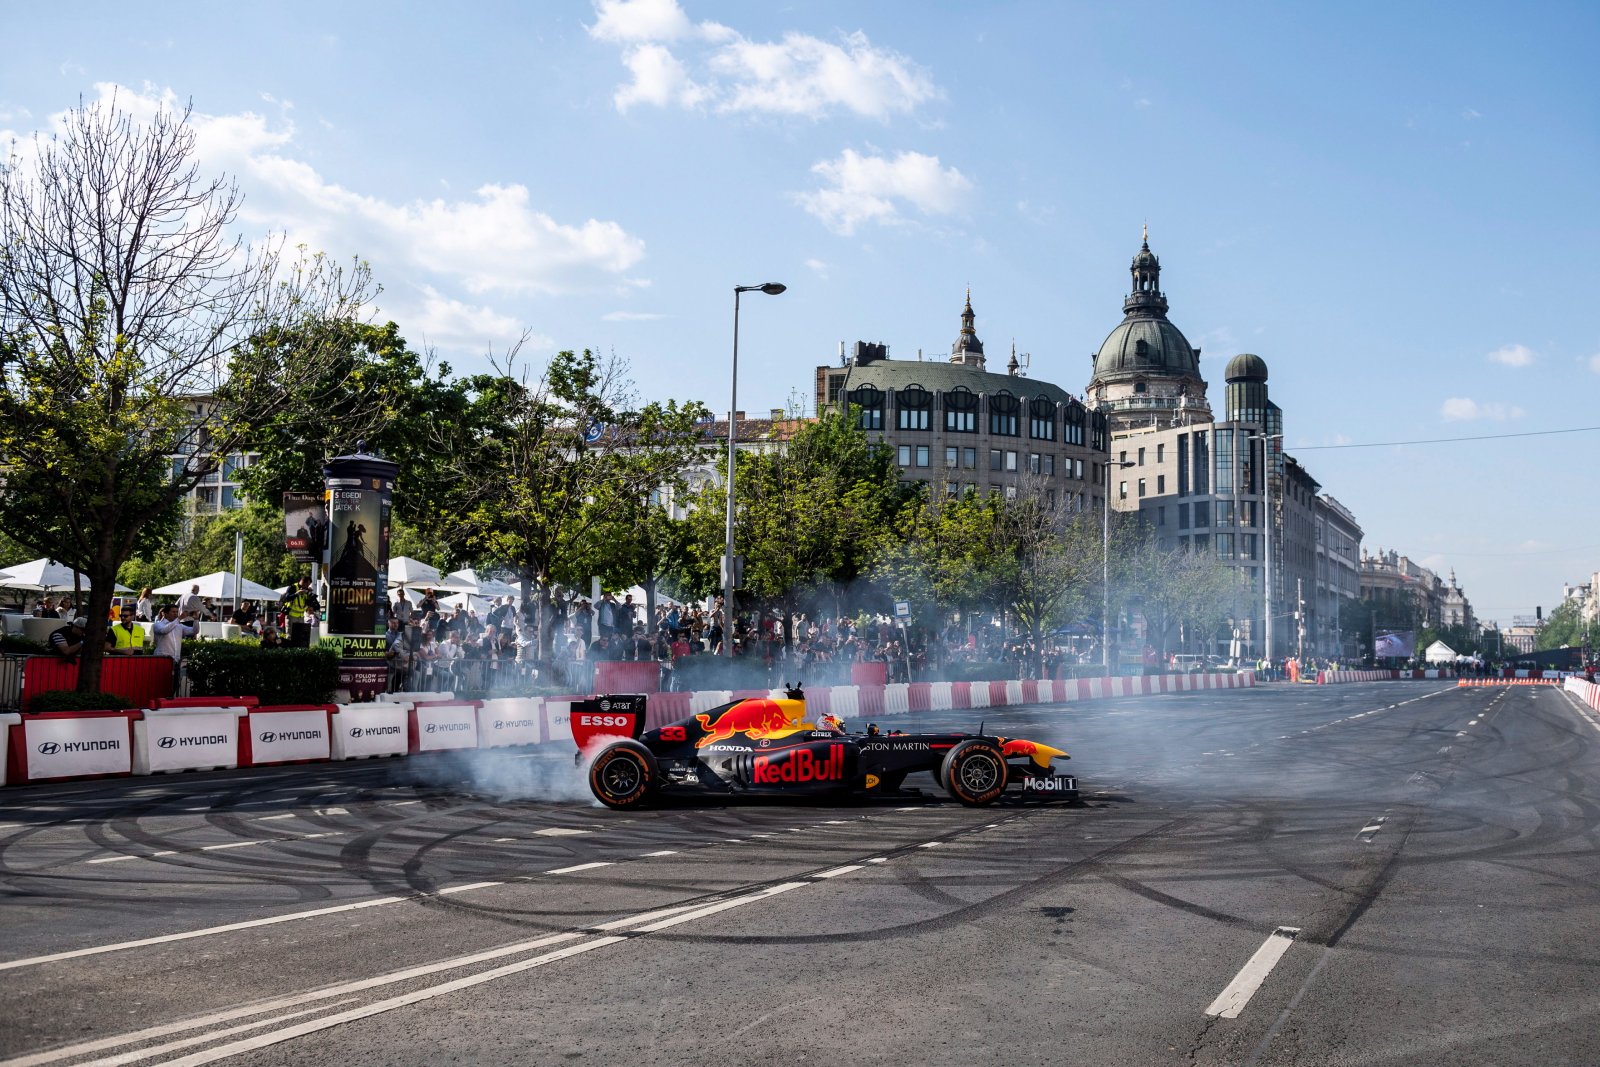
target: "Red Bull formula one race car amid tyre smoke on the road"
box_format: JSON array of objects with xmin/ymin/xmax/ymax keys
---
[{"xmin": 571, "ymin": 689, "xmax": 1078, "ymax": 808}]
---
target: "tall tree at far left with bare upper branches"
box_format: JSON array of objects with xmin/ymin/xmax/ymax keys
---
[{"xmin": 0, "ymin": 101, "xmax": 370, "ymax": 691}]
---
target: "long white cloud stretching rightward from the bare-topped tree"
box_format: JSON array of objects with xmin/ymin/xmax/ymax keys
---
[{"xmin": 67, "ymin": 85, "xmax": 645, "ymax": 302}]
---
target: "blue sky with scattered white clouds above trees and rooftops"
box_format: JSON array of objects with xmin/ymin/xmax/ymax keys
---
[{"xmin": 0, "ymin": 0, "xmax": 1600, "ymax": 624}]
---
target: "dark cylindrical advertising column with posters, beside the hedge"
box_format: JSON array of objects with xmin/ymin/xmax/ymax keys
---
[{"xmin": 323, "ymin": 453, "xmax": 400, "ymax": 699}]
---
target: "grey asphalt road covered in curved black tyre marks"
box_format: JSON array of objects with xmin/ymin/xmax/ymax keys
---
[{"xmin": 0, "ymin": 681, "xmax": 1600, "ymax": 1067}]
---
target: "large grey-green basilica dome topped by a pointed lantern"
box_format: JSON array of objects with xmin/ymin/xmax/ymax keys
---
[{"xmin": 1086, "ymin": 230, "xmax": 1211, "ymax": 434}]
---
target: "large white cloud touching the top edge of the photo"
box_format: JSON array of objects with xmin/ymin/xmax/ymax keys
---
[{"xmin": 589, "ymin": 0, "xmax": 939, "ymax": 118}]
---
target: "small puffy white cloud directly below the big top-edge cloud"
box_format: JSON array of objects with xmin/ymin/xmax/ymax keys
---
[{"xmin": 795, "ymin": 149, "xmax": 973, "ymax": 237}]
